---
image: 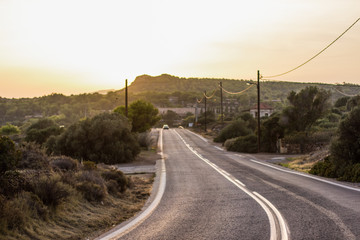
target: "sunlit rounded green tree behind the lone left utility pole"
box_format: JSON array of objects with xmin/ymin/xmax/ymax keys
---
[{"xmin": 114, "ymin": 100, "xmax": 160, "ymax": 132}]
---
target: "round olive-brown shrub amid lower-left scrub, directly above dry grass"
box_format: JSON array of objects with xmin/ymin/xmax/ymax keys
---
[{"xmin": 32, "ymin": 175, "xmax": 70, "ymax": 208}]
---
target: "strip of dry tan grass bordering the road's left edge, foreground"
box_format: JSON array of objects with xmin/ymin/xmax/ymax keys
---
[{"xmin": 0, "ymin": 176, "xmax": 153, "ymax": 240}]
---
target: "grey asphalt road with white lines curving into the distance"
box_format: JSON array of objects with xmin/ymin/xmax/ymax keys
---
[{"xmin": 100, "ymin": 129, "xmax": 360, "ymax": 239}]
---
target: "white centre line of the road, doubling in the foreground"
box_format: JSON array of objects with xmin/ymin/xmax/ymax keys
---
[{"xmin": 175, "ymin": 131, "xmax": 289, "ymax": 240}]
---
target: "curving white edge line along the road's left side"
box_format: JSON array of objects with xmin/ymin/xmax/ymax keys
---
[{"xmin": 97, "ymin": 129, "xmax": 166, "ymax": 240}]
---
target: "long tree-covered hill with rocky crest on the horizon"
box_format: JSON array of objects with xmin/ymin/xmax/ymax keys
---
[{"xmin": 129, "ymin": 74, "xmax": 360, "ymax": 102}]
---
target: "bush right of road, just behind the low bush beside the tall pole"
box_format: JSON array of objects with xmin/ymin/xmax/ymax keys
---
[{"xmin": 214, "ymin": 119, "xmax": 252, "ymax": 143}]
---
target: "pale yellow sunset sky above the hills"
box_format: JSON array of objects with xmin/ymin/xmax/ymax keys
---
[{"xmin": 0, "ymin": 0, "xmax": 360, "ymax": 98}]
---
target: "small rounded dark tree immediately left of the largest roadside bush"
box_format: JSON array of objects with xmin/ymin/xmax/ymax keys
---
[{"xmin": 25, "ymin": 118, "xmax": 62, "ymax": 144}]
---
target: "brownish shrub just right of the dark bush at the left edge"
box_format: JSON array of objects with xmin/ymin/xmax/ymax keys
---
[{"xmin": 17, "ymin": 143, "xmax": 49, "ymax": 170}]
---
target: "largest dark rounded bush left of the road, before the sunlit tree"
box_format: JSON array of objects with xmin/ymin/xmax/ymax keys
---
[{"xmin": 53, "ymin": 113, "xmax": 140, "ymax": 164}]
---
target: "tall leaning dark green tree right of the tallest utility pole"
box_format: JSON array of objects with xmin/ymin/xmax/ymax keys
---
[{"xmin": 282, "ymin": 86, "xmax": 330, "ymax": 132}]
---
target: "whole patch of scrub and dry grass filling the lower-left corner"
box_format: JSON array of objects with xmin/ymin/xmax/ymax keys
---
[{"xmin": 0, "ymin": 137, "xmax": 152, "ymax": 240}]
